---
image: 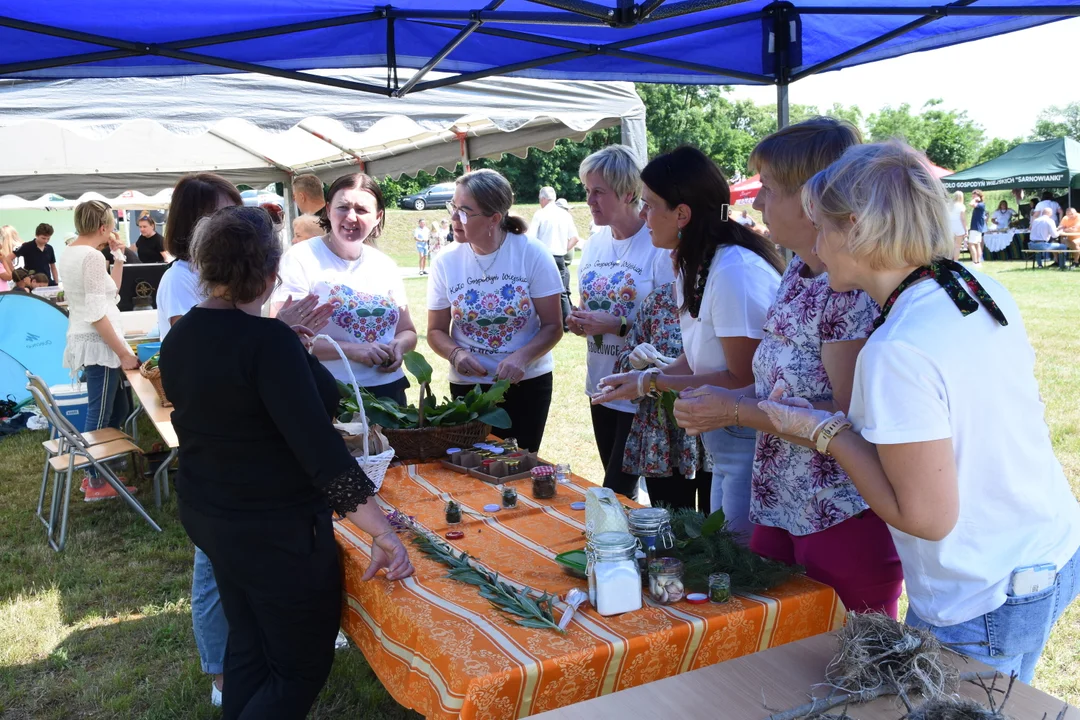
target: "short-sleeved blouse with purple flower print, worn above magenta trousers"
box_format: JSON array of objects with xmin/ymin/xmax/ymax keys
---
[{"xmin": 750, "ymin": 256, "xmax": 879, "ymax": 535}]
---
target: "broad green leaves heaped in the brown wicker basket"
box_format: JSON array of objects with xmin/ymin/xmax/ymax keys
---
[{"xmin": 338, "ymin": 351, "xmax": 510, "ymax": 430}]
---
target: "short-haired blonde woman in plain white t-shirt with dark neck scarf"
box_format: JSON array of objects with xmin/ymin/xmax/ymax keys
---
[{"xmin": 760, "ymin": 142, "xmax": 1080, "ymax": 682}]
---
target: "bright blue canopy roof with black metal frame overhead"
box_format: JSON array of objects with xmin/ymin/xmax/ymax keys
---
[{"xmin": 0, "ymin": 0, "xmax": 1080, "ymax": 124}]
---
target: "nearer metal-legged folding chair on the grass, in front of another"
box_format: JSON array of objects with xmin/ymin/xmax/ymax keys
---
[{"xmin": 27, "ymin": 384, "xmax": 161, "ymax": 552}]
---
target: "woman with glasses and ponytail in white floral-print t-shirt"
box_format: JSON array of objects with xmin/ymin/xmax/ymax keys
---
[{"xmin": 428, "ymin": 169, "xmax": 563, "ymax": 451}]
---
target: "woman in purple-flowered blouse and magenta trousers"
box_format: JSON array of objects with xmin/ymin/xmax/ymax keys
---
[{"xmin": 675, "ymin": 118, "xmax": 903, "ymax": 617}]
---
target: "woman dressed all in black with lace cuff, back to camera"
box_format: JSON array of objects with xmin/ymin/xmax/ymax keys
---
[{"xmin": 161, "ymin": 207, "xmax": 413, "ymax": 720}]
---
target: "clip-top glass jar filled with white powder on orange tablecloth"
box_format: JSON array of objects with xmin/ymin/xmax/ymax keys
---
[{"xmin": 591, "ymin": 533, "xmax": 642, "ymax": 615}]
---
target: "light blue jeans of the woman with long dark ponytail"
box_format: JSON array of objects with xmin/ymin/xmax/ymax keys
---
[{"xmin": 701, "ymin": 426, "xmax": 757, "ymax": 543}]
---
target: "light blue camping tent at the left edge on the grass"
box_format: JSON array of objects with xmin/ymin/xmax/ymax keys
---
[{"xmin": 0, "ymin": 291, "xmax": 71, "ymax": 403}]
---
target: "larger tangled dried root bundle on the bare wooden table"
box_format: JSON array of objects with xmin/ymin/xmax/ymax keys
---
[{"xmin": 825, "ymin": 613, "xmax": 960, "ymax": 702}]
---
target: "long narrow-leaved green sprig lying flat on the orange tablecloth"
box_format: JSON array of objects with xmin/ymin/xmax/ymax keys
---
[{"xmin": 413, "ymin": 532, "xmax": 565, "ymax": 634}]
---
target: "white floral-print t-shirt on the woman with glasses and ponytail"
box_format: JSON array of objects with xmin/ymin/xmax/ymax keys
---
[{"xmin": 428, "ymin": 233, "xmax": 563, "ymax": 383}]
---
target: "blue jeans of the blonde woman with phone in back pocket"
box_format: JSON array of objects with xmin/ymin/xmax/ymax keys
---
[{"xmin": 904, "ymin": 551, "xmax": 1080, "ymax": 683}]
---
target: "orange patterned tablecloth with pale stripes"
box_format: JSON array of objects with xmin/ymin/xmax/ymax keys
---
[{"xmin": 336, "ymin": 464, "xmax": 843, "ymax": 720}]
